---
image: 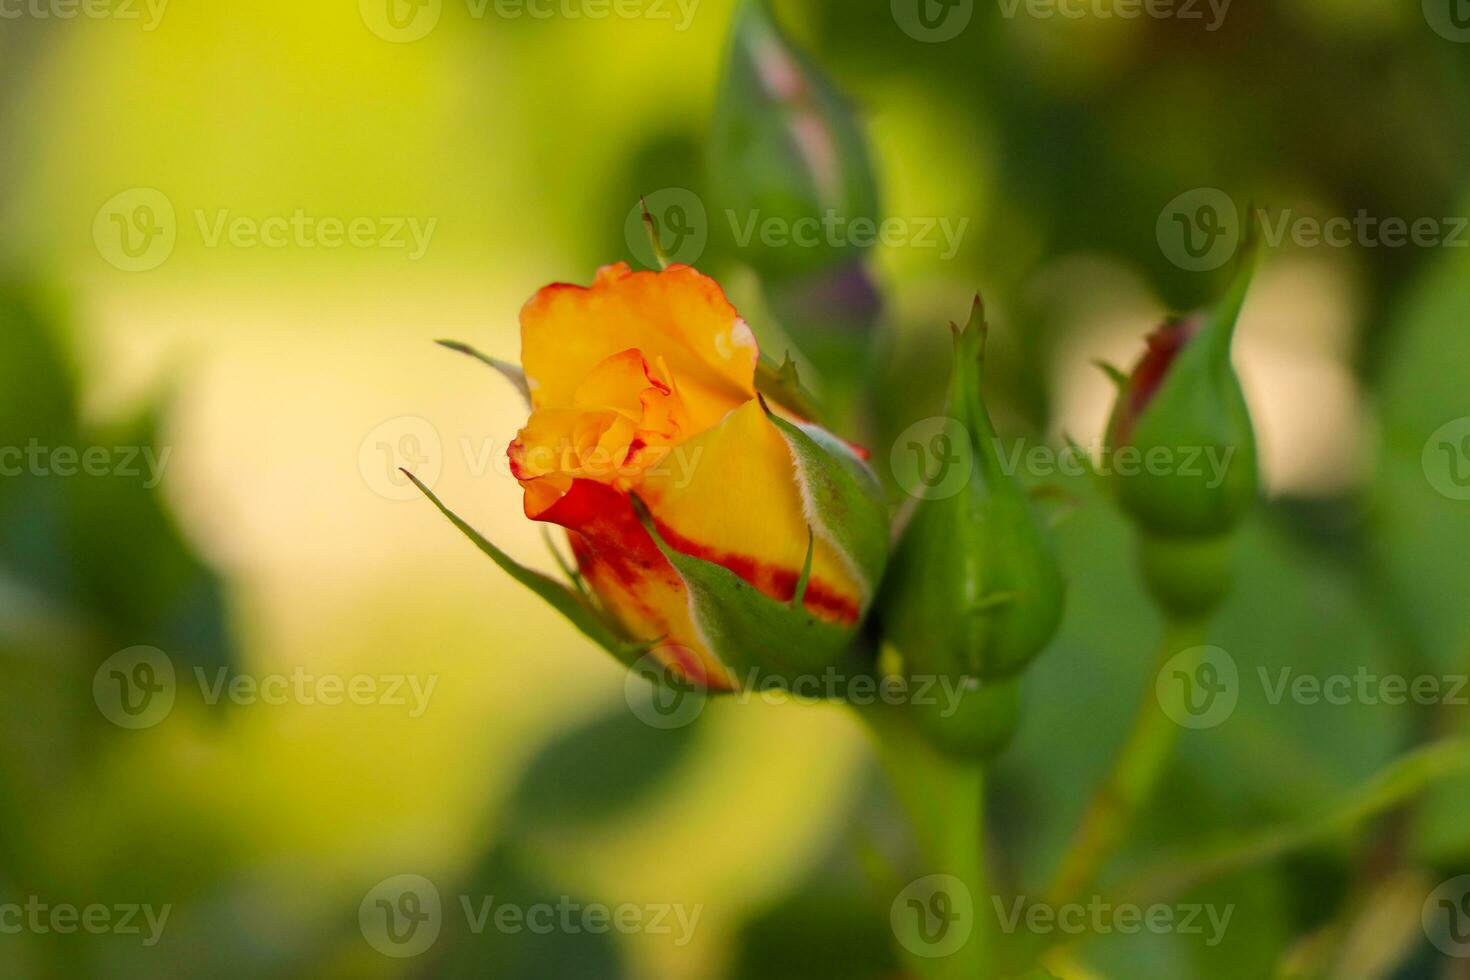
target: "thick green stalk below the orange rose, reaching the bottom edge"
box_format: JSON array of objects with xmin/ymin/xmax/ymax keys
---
[{"xmin": 858, "ymin": 705, "xmax": 997, "ymax": 980}]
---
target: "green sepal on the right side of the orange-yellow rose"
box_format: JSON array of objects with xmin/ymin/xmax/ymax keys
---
[{"xmin": 761, "ymin": 400, "xmax": 888, "ymax": 605}]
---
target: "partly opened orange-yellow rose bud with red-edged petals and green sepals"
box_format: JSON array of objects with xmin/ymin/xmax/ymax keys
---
[{"xmin": 420, "ymin": 263, "xmax": 888, "ymax": 691}]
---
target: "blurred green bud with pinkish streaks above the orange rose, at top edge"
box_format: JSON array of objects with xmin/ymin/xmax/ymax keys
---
[{"xmin": 710, "ymin": 0, "xmax": 878, "ymax": 281}]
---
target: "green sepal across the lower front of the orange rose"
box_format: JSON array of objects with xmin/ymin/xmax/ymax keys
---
[{"xmin": 629, "ymin": 497, "xmax": 857, "ymax": 686}]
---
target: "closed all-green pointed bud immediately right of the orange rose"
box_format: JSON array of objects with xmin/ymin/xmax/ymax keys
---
[{"xmin": 881, "ymin": 297, "xmax": 1064, "ymax": 701}]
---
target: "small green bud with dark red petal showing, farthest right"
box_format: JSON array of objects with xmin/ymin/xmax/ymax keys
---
[{"xmin": 1107, "ymin": 258, "xmax": 1257, "ymax": 538}]
